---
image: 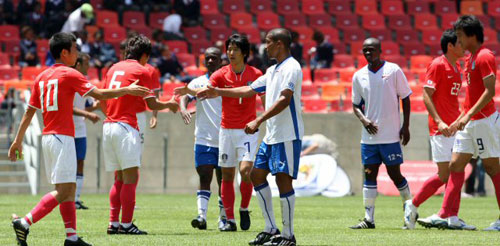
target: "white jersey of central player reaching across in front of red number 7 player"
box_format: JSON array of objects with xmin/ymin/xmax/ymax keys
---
[{"xmin": 250, "ymin": 57, "xmax": 304, "ymax": 144}]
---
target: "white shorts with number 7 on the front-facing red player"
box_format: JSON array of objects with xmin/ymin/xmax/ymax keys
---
[{"xmin": 219, "ymin": 127, "xmax": 259, "ymax": 167}]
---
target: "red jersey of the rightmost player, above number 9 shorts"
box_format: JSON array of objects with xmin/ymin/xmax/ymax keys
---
[{"xmin": 464, "ymin": 46, "xmax": 497, "ymax": 120}]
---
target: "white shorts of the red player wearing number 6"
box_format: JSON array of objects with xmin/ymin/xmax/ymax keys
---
[{"xmin": 102, "ymin": 122, "xmax": 142, "ymax": 172}]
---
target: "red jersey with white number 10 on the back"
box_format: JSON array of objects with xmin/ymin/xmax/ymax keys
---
[{"xmin": 29, "ymin": 64, "xmax": 95, "ymax": 137}]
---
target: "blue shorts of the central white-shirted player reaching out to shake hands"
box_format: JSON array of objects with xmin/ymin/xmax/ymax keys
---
[{"xmin": 254, "ymin": 140, "xmax": 302, "ymax": 179}]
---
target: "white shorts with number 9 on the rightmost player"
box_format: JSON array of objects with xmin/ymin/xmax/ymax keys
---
[{"xmin": 453, "ymin": 112, "xmax": 500, "ymax": 159}]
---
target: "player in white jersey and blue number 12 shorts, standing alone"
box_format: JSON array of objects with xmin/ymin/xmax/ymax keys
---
[{"xmin": 351, "ymin": 38, "xmax": 417, "ymax": 229}]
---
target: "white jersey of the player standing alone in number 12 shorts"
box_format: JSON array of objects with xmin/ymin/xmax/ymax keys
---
[{"xmin": 352, "ymin": 61, "xmax": 411, "ymax": 144}]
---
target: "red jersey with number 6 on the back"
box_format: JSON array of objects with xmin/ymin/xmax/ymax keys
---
[{"xmin": 104, "ymin": 59, "xmax": 154, "ymax": 130}]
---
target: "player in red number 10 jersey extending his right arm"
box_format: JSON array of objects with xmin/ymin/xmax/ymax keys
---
[{"xmin": 9, "ymin": 33, "xmax": 149, "ymax": 246}]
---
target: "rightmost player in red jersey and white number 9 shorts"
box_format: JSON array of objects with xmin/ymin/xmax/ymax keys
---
[{"xmin": 430, "ymin": 15, "xmax": 500, "ymax": 231}]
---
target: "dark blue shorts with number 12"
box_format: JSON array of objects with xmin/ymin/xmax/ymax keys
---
[{"xmin": 361, "ymin": 142, "xmax": 403, "ymax": 166}]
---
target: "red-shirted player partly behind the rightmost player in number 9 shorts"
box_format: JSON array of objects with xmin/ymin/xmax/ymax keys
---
[{"xmin": 407, "ymin": 29, "xmax": 464, "ymax": 229}]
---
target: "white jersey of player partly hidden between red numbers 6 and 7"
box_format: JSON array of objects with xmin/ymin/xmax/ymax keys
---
[{"xmin": 188, "ymin": 74, "xmax": 222, "ymax": 148}]
